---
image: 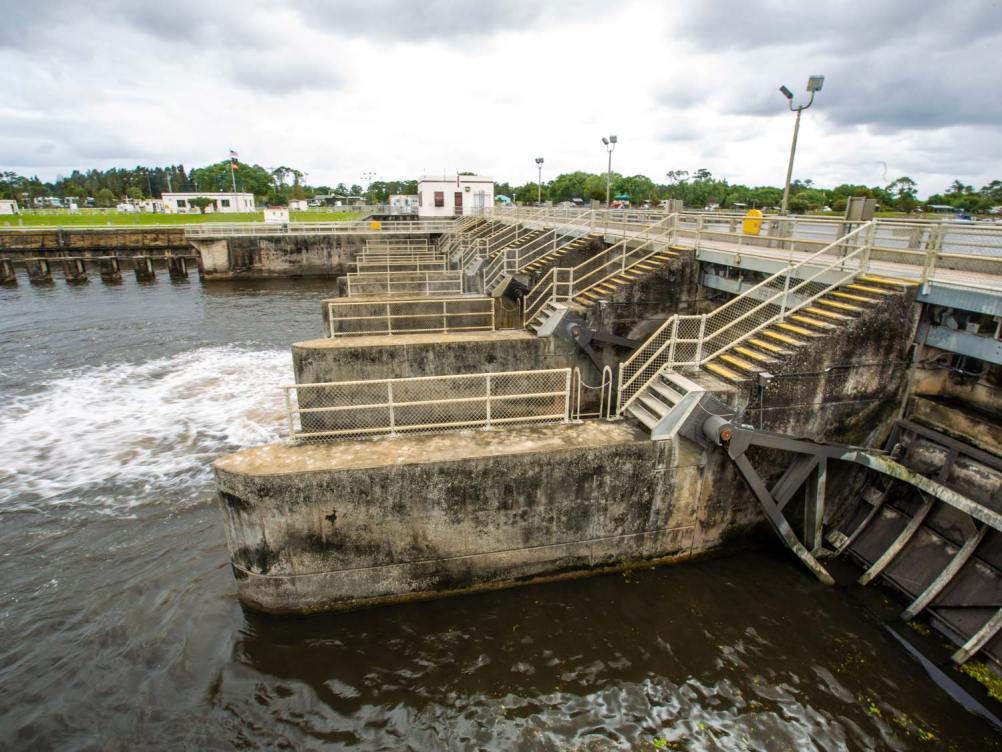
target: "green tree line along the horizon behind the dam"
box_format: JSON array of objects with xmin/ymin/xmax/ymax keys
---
[{"xmin": 0, "ymin": 160, "xmax": 1002, "ymax": 213}]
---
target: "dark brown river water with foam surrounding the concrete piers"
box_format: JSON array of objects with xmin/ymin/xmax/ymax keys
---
[{"xmin": 0, "ymin": 278, "xmax": 999, "ymax": 750}]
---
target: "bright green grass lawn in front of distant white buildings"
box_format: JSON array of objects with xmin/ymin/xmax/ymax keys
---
[{"xmin": 0, "ymin": 210, "xmax": 365, "ymax": 229}]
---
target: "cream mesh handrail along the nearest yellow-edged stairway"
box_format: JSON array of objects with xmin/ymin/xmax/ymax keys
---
[{"xmin": 616, "ymin": 222, "xmax": 876, "ymax": 414}]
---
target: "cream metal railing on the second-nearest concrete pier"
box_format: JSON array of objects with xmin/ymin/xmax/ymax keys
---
[{"xmin": 327, "ymin": 298, "xmax": 495, "ymax": 337}]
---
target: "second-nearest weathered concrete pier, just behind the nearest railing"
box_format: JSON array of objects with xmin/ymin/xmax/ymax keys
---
[{"xmin": 293, "ymin": 330, "xmax": 579, "ymax": 384}]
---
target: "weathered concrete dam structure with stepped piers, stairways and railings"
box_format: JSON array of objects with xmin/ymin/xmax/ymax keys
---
[{"xmin": 215, "ymin": 210, "xmax": 1002, "ymax": 662}]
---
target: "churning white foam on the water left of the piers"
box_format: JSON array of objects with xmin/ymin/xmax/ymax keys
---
[{"xmin": 0, "ymin": 347, "xmax": 293, "ymax": 513}]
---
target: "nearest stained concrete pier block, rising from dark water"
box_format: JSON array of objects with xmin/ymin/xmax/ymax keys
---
[{"xmin": 215, "ymin": 422, "xmax": 699, "ymax": 613}]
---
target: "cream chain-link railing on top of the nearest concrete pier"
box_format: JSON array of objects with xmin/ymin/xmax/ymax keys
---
[{"xmin": 286, "ymin": 368, "xmax": 571, "ymax": 441}]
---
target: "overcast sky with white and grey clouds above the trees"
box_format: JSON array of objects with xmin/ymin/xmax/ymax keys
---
[{"xmin": 0, "ymin": 0, "xmax": 1002, "ymax": 196}]
